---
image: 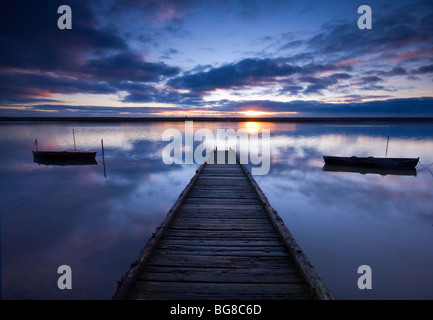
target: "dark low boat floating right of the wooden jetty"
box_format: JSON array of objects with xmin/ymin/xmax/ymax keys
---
[{"xmin": 323, "ymin": 156, "xmax": 419, "ymax": 169}]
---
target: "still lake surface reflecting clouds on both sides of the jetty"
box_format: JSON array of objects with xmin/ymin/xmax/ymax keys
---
[{"xmin": 0, "ymin": 122, "xmax": 433, "ymax": 299}]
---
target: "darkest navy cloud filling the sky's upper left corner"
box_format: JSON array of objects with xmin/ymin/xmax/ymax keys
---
[{"xmin": 0, "ymin": 0, "xmax": 127, "ymax": 71}]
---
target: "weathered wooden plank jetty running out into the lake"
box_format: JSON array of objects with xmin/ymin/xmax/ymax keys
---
[{"xmin": 113, "ymin": 151, "xmax": 333, "ymax": 300}]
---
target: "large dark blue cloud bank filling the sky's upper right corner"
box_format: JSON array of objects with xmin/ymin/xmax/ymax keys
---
[{"xmin": 270, "ymin": 1, "xmax": 433, "ymax": 92}]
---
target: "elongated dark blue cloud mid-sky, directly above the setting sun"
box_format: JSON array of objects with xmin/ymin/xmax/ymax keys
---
[{"xmin": 167, "ymin": 58, "xmax": 352, "ymax": 95}]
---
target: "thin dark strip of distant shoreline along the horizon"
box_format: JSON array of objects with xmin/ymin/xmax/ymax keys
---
[{"xmin": 0, "ymin": 117, "xmax": 433, "ymax": 123}]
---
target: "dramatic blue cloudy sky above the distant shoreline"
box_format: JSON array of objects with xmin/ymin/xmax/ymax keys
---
[{"xmin": 0, "ymin": 0, "xmax": 433, "ymax": 116}]
